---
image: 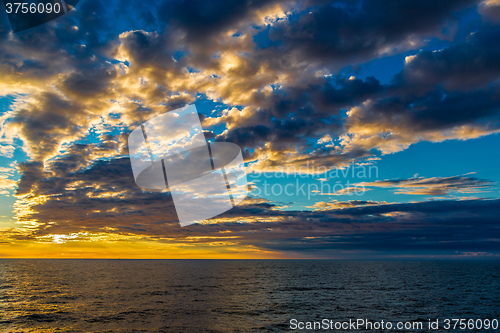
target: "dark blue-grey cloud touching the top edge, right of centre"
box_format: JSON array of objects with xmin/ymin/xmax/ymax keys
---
[{"xmin": 269, "ymin": 0, "xmax": 477, "ymax": 64}]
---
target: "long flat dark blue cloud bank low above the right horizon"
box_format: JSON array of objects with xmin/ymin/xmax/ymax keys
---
[{"xmin": 174, "ymin": 200, "xmax": 500, "ymax": 257}]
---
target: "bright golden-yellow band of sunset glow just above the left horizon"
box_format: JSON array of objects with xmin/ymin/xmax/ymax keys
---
[{"xmin": 0, "ymin": 233, "xmax": 285, "ymax": 259}]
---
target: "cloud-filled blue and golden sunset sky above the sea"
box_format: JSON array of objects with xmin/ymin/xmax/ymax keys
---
[{"xmin": 0, "ymin": 0, "xmax": 500, "ymax": 259}]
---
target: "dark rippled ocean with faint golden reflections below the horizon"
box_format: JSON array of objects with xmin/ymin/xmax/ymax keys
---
[{"xmin": 0, "ymin": 259, "xmax": 500, "ymax": 332}]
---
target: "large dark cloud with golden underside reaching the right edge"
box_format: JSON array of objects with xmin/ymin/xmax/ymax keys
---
[{"xmin": 345, "ymin": 24, "xmax": 500, "ymax": 152}]
